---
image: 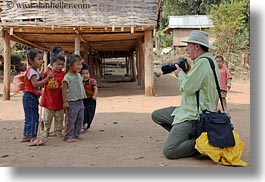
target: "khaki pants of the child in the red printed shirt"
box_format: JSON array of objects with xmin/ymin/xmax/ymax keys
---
[{"xmin": 44, "ymin": 108, "xmax": 64, "ymax": 134}]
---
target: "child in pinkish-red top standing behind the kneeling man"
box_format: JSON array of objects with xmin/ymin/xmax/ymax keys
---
[{"xmin": 215, "ymin": 56, "xmax": 232, "ymax": 110}]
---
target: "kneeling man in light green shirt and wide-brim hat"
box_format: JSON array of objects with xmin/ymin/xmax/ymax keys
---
[{"xmin": 152, "ymin": 30, "xmax": 219, "ymax": 159}]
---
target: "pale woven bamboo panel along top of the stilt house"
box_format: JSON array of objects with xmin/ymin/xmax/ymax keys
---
[{"xmin": 0, "ymin": 0, "xmax": 160, "ymax": 27}]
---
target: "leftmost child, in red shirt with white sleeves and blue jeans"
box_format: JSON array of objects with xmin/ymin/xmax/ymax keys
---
[{"xmin": 21, "ymin": 49, "xmax": 53, "ymax": 146}]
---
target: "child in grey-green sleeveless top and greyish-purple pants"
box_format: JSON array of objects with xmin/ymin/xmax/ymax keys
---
[{"xmin": 62, "ymin": 54, "xmax": 86, "ymax": 142}]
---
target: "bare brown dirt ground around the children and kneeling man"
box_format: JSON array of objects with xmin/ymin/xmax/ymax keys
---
[{"xmin": 0, "ymin": 75, "xmax": 251, "ymax": 167}]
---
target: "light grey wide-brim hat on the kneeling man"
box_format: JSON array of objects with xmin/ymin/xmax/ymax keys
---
[{"xmin": 181, "ymin": 30, "xmax": 217, "ymax": 50}]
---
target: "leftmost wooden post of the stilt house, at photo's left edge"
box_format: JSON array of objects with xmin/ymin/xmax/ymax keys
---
[{"xmin": 3, "ymin": 31, "xmax": 11, "ymax": 100}]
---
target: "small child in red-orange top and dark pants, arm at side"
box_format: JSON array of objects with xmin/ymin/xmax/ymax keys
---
[{"xmin": 81, "ymin": 64, "xmax": 98, "ymax": 130}]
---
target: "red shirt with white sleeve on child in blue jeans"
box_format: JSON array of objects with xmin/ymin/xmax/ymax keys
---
[{"xmin": 24, "ymin": 67, "xmax": 41, "ymax": 97}]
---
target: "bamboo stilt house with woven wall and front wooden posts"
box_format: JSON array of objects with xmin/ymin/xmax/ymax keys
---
[{"xmin": 0, "ymin": 0, "xmax": 161, "ymax": 100}]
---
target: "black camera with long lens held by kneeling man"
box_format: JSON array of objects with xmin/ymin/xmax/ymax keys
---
[{"xmin": 161, "ymin": 57, "xmax": 189, "ymax": 75}]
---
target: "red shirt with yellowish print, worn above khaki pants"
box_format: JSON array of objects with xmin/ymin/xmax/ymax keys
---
[{"xmin": 40, "ymin": 70, "xmax": 66, "ymax": 110}]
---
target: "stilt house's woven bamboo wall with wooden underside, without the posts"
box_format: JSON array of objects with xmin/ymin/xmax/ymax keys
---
[{"xmin": 0, "ymin": 0, "xmax": 161, "ymax": 52}]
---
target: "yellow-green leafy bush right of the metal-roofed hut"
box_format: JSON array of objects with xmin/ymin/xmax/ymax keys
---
[{"xmin": 210, "ymin": 0, "xmax": 249, "ymax": 55}]
